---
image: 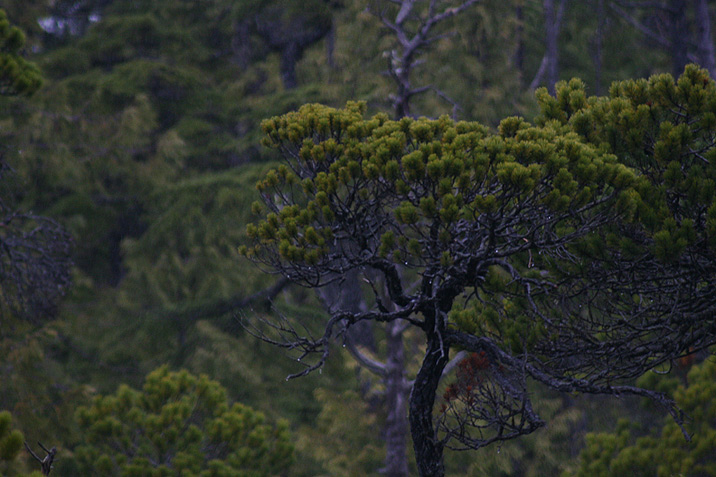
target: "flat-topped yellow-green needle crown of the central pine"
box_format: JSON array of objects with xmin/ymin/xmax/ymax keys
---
[{"xmin": 242, "ymin": 101, "xmax": 640, "ymax": 276}]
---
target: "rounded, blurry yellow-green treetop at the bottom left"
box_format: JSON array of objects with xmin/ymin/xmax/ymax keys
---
[{"xmin": 75, "ymin": 366, "xmax": 293, "ymax": 476}]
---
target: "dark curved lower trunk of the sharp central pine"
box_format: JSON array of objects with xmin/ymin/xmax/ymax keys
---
[{"xmin": 410, "ymin": 332, "xmax": 450, "ymax": 477}]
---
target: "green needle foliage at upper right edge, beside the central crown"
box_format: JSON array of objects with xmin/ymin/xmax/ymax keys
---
[{"xmin": 537, "ymin": 65, "xmax": 716, "ymax": 263}]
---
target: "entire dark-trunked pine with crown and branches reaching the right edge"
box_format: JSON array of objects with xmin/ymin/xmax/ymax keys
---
[{"xmin": 243, "ymin": 67, "xmax": 716, "ymax": 475}]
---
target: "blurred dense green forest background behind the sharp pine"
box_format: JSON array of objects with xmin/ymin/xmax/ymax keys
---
[{"xmin": 0, "ymin": 0, "xmax": 716, "ymax": 476}]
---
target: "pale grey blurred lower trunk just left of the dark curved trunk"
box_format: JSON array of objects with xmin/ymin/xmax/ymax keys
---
[{"xmin": 383, "ymin": 321, "xmax": 409, "ymax": 477}]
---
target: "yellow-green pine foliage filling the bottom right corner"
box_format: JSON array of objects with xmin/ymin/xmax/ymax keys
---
[{"xmin": 576, "ymin": 359, "xmax": 716, "ymax": 477}]
